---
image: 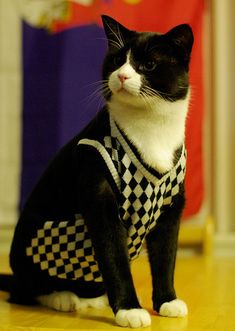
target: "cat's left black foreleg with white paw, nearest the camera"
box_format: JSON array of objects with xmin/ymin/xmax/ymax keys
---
[{"xmin": 83, "ymin": 180, "xmax": 151, "ymax": 327}]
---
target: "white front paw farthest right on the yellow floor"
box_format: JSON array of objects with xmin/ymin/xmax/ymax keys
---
[{"xmin": 159, "ymin": 299, "xmax": 188, "ymax": 317}]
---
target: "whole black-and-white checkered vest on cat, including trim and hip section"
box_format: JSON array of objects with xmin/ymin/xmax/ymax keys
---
[{"xmin": 26, "ymin": 118, "xmax": 186, "ymax": 281}]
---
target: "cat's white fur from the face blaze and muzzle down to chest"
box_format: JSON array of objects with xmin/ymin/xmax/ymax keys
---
[{"xmin": 108, "ymin": 53, "xmax": 190, "ymax": 173}]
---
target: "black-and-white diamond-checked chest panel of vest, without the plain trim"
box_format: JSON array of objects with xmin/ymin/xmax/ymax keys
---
[{"xmin": 105, "ymin": 137, "xmax": 186, "ymax": 259}]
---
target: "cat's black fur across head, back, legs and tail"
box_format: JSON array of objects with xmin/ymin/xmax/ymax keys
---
[{"xmin": 0, "ymin": 16, "xmax": 193, "ymax": 324}]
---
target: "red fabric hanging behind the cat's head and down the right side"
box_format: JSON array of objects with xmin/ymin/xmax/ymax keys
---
[{"xmin": 54, "ymin": 0, "xmax": 204, "ymax": 219}]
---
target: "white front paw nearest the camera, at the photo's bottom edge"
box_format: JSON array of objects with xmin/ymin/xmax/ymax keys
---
[{"xmin": 115, "ymin": 309, "xmax": 151, "ymax": 328}]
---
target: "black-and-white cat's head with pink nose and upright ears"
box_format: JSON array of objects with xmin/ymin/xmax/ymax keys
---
[{"xmin": 102, "ymin": 15, "xmax": 193, "ymax": 105}]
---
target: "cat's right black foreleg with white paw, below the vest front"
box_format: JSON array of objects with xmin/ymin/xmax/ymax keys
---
[{"xmin": 147, "ymin": 193, "xmax": 188, "ymax": 317}]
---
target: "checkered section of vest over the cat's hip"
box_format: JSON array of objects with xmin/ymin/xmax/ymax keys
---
[{"xmin": 26, "ymin": 215, "xmax": 102, "ymax": 281}]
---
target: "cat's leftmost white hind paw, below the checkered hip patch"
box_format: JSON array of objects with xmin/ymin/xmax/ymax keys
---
[{"xmin": 37, "ymin": 291, "xmax": 80, "ymax": 312}]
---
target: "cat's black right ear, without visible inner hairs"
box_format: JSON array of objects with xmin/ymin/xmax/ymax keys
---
[{"xmin": 166, "ymin": 24, "xmax": 194, "ymax": 59}]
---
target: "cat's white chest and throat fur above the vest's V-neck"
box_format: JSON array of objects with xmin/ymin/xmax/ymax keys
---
[{"xmin": 109, "ymin": 98, "xmax": 188, "ymax": 173}]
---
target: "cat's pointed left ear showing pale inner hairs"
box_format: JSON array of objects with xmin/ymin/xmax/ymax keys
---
[{"xmin": 101, "ymin": 15, "xmax": 134, "ymax": 50}]
